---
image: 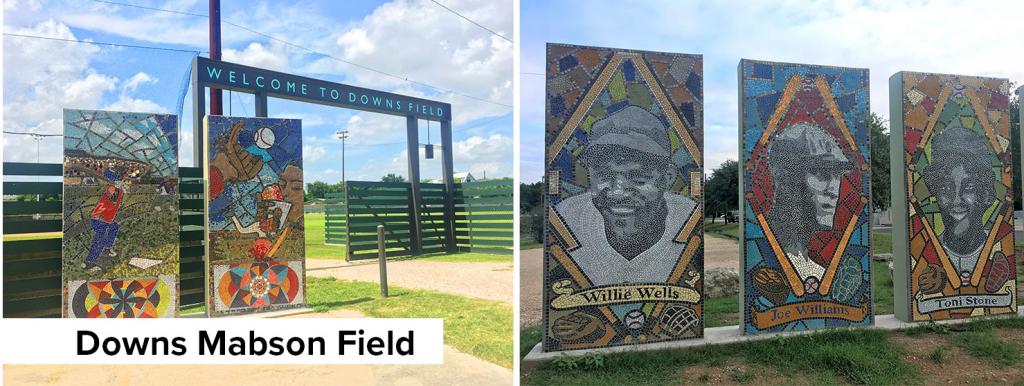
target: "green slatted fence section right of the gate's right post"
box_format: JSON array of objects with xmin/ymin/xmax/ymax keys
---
[{"xmin": 461, "ymin": 179, "xmax": 516, "ymax": 255}]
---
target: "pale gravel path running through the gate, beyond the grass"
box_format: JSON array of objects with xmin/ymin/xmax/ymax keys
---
[{"xmin": 306, "ymin": 259, "xmax": 513, "ymax": 305}]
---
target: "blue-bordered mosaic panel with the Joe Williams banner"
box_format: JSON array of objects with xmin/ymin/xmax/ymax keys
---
[{"xmin": 739, "ymin": 59, "xmax": 873, "ymax": 334}]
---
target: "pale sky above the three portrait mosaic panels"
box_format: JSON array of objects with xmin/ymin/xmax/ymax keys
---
[{"xmin": 520, "ymin": 0, "xmax": 1024, "ymax": 182}]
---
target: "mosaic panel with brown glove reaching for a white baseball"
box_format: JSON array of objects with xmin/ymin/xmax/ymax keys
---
[{"xmin": 205, "ymin": 116, "xmax": 305, "ymax": 315}]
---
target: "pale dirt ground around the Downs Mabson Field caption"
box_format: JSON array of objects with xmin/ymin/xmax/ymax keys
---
[{"xmin": 3, "ymin": 310, "xmax": 513, "ymax": 386}]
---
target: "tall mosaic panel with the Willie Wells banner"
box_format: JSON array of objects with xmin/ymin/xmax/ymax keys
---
[{"xmin": 544, "ymin": 44, "xmax": 703, "ymax": 351}]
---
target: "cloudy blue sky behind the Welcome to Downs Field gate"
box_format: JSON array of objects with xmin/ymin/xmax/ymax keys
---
[{"xmin": 3, "ymin": 0, "xmax": 513, "ymax": 182}]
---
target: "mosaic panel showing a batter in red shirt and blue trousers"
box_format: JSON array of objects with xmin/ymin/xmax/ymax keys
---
[{"xmin": 61, "ymin": 110, "xmax": 178, "ymax": 317}]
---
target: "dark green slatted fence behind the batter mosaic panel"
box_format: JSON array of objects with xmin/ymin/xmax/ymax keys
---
[{"xmin": 3, "ymin": 162, "xmax": 205, "ymax": 317}]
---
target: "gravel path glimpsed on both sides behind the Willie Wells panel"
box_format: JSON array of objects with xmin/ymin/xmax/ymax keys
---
[{"xmin": 519, "ymin": 235, "xmax": 739, "ymax": 326}]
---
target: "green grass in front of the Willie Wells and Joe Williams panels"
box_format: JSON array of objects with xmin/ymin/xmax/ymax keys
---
[{"xmin": 522, "ymin": 330, "xmax": 918, "ymax": 385}]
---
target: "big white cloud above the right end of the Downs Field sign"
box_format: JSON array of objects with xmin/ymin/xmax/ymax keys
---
[{"xmin": 307, "ymin": 0, "xmax": 513, "ymax": 125}]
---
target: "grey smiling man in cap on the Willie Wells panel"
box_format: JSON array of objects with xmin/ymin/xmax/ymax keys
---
[{"xmin": 555, "ymin": 106, "xmax": 697, "ymax": 286}]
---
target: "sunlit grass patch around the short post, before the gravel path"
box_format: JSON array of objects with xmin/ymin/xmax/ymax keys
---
[{"xmin": 306, "ymin": 277, "xmax": 513, "ymax": 369}]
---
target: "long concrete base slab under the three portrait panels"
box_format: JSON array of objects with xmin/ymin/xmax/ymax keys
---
[{"xmin": 520, "ymin": 307, "xmax": 1024, "ymax": 370}]
